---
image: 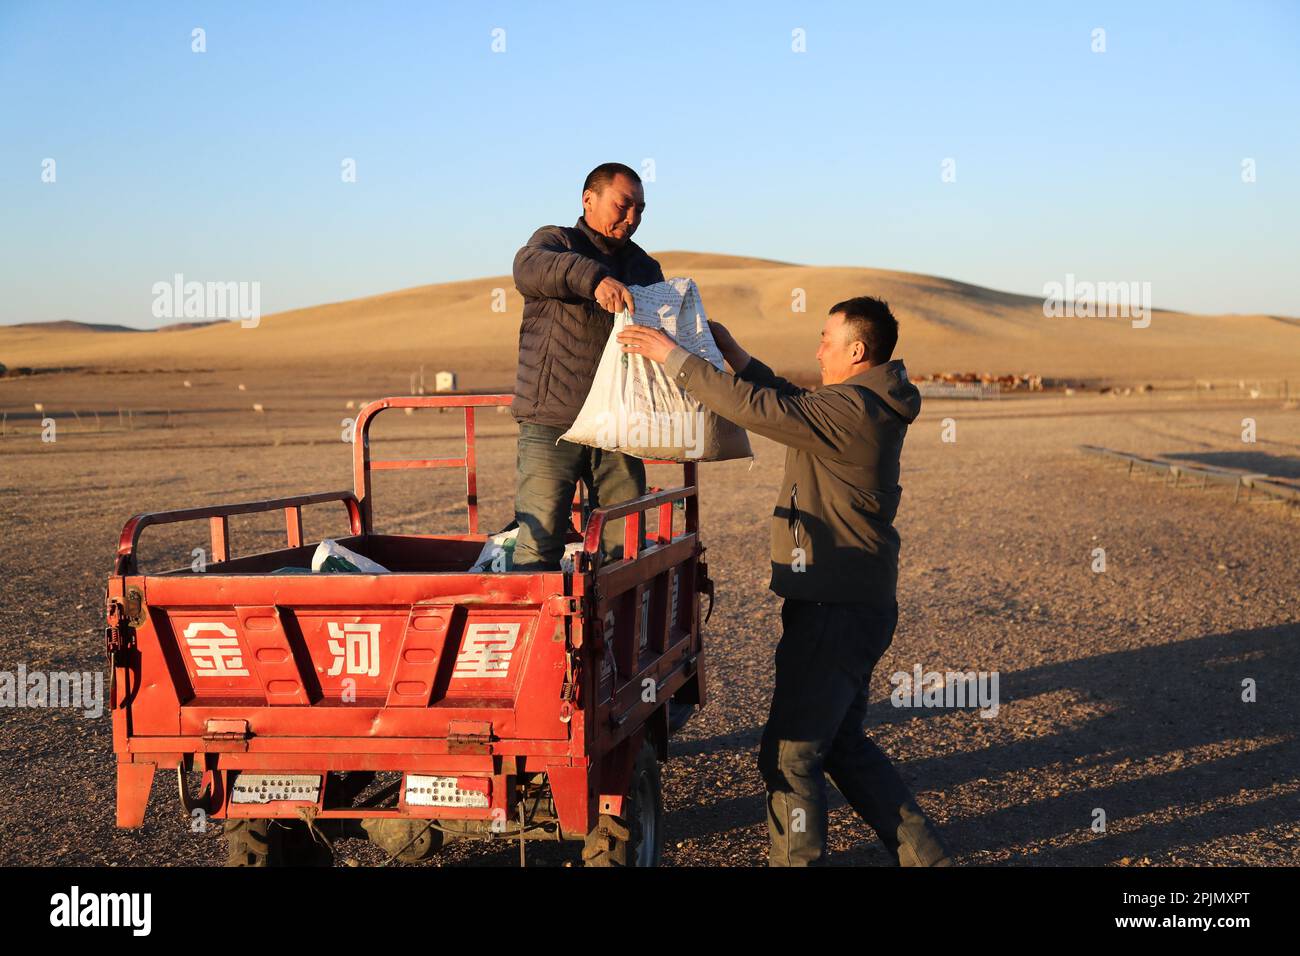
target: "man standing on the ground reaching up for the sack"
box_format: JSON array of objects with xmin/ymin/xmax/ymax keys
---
[{"xmin": 619, "ymin": 297, "xmax": 952, "ymax": 866}]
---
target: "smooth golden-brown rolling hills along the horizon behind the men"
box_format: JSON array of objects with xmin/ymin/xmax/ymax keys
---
[{"xmin": 0, "ymin": 251, "xmax": 1300, "ymax": 388}]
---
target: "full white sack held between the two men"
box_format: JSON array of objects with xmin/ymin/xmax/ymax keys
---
[{"xmin": 560, "ymin": 278, "xmax": 754, "ymax": 462}]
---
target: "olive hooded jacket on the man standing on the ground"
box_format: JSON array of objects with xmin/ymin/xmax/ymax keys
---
[{"xmin": 664, "ymin": 346, "xmax": 920, "ymax": 609}]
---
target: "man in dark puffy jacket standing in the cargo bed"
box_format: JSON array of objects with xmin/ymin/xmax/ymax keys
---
[{"xmin": 510, "ymin": 163, "xmax": 663, "ymax": 571}]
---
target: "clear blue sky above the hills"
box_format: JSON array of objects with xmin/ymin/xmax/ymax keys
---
[{"xmin": 0, "ymin": 0, "xmax": 1300, "ymax": 326}]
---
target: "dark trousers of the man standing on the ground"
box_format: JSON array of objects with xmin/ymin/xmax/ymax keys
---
[{"xmin": 758, "ymin": 598, "xmax": 952, "ymax": 866}]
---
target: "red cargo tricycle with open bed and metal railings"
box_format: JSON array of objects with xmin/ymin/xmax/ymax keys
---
[{"xmin": 107, "ymin": 395, "xmax": 712, "ymax": 866}]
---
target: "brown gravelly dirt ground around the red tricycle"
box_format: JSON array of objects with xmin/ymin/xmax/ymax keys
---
[{"xmin": 0, "ymin": 371, "xmax": 1300, "ymax": 866}]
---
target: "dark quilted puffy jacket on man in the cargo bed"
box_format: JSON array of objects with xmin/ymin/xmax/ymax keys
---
[{"xmin": 510, "ymin": 219, "xmax": 663, "ymax": 428}]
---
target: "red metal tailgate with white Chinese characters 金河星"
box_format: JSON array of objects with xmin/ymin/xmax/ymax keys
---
[{"xmin": 114, "ymin": 572, "xmax": 568, "ymax": 752}]
